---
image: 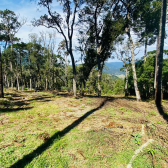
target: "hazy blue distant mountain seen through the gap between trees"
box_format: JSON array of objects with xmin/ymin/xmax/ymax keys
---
[{"xmin": 103, "ymin": 62, "xmax": 125, "ymax": 75}]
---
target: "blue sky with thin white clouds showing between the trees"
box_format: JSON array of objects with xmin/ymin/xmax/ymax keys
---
[{"xmin": 0, "ymin": 0, "xmax": 168, "ymax": 62}]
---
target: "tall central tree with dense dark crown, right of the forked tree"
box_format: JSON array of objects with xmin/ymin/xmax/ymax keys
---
[{"xmin": 79, "ymin": 0, "xmax": 123, "ymax": 96}]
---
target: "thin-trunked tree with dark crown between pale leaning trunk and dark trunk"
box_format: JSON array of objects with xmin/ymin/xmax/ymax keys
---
[{"xmin": 133, "ymin": 0, "xmax": 161, "ymax": 63}]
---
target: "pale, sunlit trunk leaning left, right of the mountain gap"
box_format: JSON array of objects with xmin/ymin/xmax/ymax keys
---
[{"xmin": 126, "ymin": 28, "xmax": 141, "ymax": 101}]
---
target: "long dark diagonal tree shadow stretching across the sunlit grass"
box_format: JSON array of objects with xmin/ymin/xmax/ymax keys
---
[{"xmin": 10, "ymin": 99, "xmax": 107, "ymax": 168}]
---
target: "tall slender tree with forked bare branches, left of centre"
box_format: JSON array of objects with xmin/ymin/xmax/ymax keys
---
[{"xmin": 34, "ymin": 0, "xmax": 83, "ymax": 96}]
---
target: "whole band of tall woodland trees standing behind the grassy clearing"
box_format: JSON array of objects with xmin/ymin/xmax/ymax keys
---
[{"xmin": 0, "ymin": 0, "xmax": 168, "ymax": 104}]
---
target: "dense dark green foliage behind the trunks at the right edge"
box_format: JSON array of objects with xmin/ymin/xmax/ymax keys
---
[{"xmin": 128, "ymin": 50, "xmax": 168, "ymax": 98}]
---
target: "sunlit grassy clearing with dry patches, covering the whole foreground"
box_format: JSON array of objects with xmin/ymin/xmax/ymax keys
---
[{"xmin": 0, "ymin": 91, "xmax": 168, "ymax": 168}]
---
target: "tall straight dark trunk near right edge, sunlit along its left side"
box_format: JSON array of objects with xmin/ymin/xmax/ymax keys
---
[{"xmin": 155, "ymin": 0, "xmax": 167, "ymax": 106}]
